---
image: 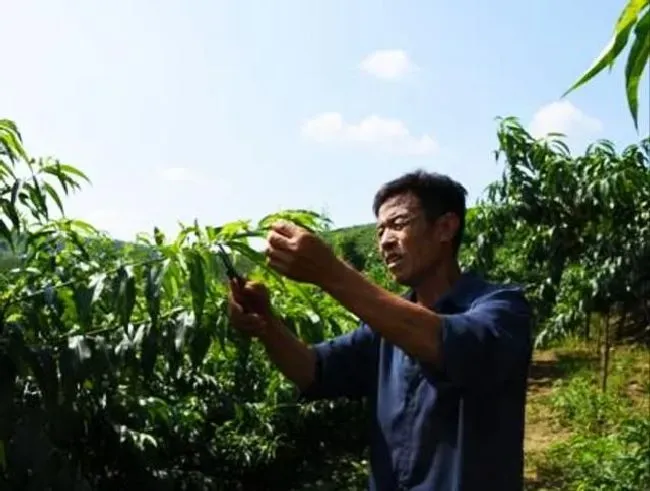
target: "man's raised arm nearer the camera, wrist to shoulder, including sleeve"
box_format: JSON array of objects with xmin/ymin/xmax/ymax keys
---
[{"xmin": 323, "ymin": 267, "xmax": 532, "ymax": 386}]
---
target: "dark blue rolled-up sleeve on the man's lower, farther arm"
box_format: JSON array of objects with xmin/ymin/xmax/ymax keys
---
[{"xmin": 299, "ymin": 324, "xmax": 378, "ymax": 402}]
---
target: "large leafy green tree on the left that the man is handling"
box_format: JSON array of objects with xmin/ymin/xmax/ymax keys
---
[{"xmin": 0, "ymin": 121, "xmax": 364, "ymax": 490}]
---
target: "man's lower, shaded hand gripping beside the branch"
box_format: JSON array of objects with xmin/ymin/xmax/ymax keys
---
[{"xmin": 228, "ymin": 281, "xmax": 273, "ymax": 337}]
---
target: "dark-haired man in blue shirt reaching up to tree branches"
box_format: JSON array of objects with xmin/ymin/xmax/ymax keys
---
[{"xmin": 229, "ymin": 171, "xmax": 532, "ymax": 491}]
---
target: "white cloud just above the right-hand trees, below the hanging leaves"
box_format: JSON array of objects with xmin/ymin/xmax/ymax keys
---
[{"xmin": 528, "ymin": 100, "xmax": 603, "ymax": 138}]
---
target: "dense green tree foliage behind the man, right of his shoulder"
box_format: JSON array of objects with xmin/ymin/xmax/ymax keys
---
[{"xmin": 332, "ymin": 118, "xmax": 650, "ymax": 345}]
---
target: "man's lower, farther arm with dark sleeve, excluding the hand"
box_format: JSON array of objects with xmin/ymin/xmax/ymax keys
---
[{"xmin": 260, "ymin": 319, "xmax": 378, "ymax": 400}]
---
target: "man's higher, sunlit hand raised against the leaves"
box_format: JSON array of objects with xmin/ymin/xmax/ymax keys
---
[{"xmin": 266, "ymin": 221, "xmax": 343, "ymax": 287}]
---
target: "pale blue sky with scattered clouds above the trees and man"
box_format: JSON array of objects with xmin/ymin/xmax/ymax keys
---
[{"xmin": 0, "ymin": 0, "xmax": 648, "ymax": 239}]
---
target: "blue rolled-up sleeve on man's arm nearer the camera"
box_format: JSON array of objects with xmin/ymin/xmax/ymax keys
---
[{"xmin": 441, "ymin": 287, "xmax": 532, "ymax": 389}]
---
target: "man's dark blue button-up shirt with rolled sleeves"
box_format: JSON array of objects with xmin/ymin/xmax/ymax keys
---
[{"xmin": 301, "ymin": 273, "xmax": 532, "ymax": 491}]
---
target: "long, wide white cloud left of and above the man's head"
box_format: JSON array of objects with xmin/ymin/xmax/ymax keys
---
[{"xmin": 302, "ymin": 112, "xmax": 438, "ymax": 155}]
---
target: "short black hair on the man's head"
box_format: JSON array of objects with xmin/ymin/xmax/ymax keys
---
[{"xmin": 372, "ymin": 169, "xmax": 467, "ymax": 255}]
